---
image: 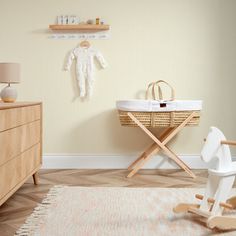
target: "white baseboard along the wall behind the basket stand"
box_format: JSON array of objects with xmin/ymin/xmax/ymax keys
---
[{"xmin": 42, "ymin": 154, "xmax": 223, "ymax": 169}]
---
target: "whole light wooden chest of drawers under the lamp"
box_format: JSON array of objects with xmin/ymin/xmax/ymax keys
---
[{"xmin": 0, "ymin": 102, "xmax": 42, "ymax": 205}]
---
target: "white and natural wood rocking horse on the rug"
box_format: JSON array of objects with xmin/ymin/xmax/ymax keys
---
[{"xmin": 173, "ymin": 127, "xmax": 236, "ymax": 230}]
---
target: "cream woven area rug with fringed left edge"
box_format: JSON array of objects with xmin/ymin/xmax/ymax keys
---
[{"xmin": 16, "ymin": 186, "xmax": 236, "ymax": 236}]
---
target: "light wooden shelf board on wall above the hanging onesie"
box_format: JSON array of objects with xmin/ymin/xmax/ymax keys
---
[{"xmin": 49, "ymin": 24, "xmax": 110, "ymax": 32}]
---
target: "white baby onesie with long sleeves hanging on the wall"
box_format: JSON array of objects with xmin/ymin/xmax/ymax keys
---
[{"xmin": 65, "ymin": 46, "xmax": 107, "ymax": 97}]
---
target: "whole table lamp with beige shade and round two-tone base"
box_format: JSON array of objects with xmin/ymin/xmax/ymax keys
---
[{"xmin": 0, "ymin": 63, "xmax": 20, "ymax": 102}]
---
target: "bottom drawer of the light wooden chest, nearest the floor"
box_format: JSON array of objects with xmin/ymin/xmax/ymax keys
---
[{"xmin": 0, "ymin": 144, "xmax": 41, "ymax": 199}]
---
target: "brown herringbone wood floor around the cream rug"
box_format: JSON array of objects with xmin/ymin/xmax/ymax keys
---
[{"xmin": 0, "ymin": 170, "xmax": 207, "ymax": 236}]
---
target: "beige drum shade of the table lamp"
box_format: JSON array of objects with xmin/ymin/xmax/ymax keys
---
[{"xmin": 0, "ymin": 63, "xmax": 20, "ymax": 84}]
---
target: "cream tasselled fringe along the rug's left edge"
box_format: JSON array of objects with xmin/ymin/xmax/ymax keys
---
[{"xmin": 15, "ymin": 185, "xmax": 66, "ymax": 236}]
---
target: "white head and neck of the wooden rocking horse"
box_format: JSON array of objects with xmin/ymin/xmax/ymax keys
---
[{"xmin": 201, "ymin": 127, "xmax": 232, "ymax": 170}]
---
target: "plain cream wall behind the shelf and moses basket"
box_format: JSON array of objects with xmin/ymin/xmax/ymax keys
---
[{"xmin": 0, "ymin": 0, "xmax": 236, "ymax": 154}]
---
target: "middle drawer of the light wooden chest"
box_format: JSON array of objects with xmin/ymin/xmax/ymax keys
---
[{"xmin": 0, "ymin": 120, "xmax": 41, "ymax": 166}]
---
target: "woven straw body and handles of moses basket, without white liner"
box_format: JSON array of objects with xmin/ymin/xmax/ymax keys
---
[{"xmin": 118, "ymin": 80, "xmax": 200, "ymax": 128}]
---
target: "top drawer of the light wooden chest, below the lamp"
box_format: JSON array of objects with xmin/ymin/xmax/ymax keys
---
[{"xmin": 0, "ymin": 105, "xmax": 41, "ymax": 132}]
